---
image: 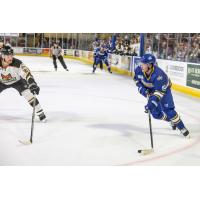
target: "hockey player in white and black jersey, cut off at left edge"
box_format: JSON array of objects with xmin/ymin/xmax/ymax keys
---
[{"xmin": 0, "ymin": 46, "xmax": 46, "ymax": 122}]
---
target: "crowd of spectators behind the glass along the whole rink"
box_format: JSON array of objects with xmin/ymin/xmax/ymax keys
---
[{"xmin": 1, "ymin": 33, "xmax": 200, "ymax": 63}]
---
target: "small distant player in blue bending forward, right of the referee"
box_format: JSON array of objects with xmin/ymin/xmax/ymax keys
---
[{"xmin": 93, "ymin": 47, "xmax": 112, "ymax": 73}]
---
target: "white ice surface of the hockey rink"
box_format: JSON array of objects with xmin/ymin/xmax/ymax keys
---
[{"xmin": 0, "ymin": 56, "xmax": 200, "ymax": 166}]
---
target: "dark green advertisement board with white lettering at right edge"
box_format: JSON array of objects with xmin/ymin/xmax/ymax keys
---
[{"xmin": 187, "ymin": 64, "xmax": 200, "ymax": 89}]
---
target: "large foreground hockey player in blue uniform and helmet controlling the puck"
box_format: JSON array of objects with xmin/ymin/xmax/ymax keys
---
[{"xmin": 134, "ymin": 54, "xmax": 189, "ymax": 138}]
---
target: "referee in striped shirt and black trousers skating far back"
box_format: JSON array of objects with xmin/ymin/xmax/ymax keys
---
[{"xmin": 50, "ymin": 42, "xmax": 69, "ymax": 71}]
